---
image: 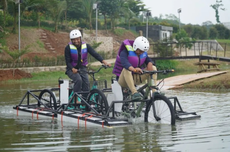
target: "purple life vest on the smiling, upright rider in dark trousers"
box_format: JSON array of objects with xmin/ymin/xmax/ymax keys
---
[{"xmin": 69, "ymin": 42, "xmax": 88, "ymax": 67}]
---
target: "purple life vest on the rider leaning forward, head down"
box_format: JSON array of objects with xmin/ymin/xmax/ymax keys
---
[{"xmin": 113, "ymin": 39, "xmax": 147, "ymax": 76}]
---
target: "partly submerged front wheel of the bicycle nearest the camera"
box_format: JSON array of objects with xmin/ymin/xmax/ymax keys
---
[{"xmin": 145, "ymin": 94, "xmax": 175, "ymax": 125}]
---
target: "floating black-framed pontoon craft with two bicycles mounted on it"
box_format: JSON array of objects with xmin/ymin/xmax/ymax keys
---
[{"xmin": 13, "ymin": 66, "xmax": 200, "ymax": 127}]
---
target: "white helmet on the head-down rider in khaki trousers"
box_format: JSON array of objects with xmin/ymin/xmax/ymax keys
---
[{"xmin": 133, "ymin": 36, "xmax": 149, "ymax": 52}]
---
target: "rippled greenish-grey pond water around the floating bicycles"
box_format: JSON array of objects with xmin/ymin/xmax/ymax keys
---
[{"xmin": 0, "ymin": 82, "xmax": 230, "ymax": 152}]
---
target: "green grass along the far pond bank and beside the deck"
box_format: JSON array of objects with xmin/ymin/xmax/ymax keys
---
[{"xmin": 4, "ymin": 59, "xmax": 230, "ymax": 91}]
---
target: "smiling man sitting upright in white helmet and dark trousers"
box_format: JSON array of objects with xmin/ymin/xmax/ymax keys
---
[{"xmin": 65, "ymin": 29, "xmax": 111, "ymax": 99}]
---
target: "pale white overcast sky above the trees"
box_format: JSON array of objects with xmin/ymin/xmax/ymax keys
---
[{"xmin": 142, "ymin": 0, "xmax": 230, "ymax": 25}]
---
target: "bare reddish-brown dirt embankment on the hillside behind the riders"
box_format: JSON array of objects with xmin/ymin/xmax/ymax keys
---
[{"xmin": 0, "ymin": 29, "xmax": 136, "ymax": 81}]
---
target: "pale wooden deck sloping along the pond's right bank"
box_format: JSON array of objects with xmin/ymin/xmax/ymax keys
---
[{"xmin": 161, "ymin": 71, "xmax": 227, "ymax": 90}]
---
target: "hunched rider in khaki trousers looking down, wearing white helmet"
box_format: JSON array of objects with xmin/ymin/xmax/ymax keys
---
[{"xmin": 113, "ymin": 36, "xmax": 157, "ymax": 100}]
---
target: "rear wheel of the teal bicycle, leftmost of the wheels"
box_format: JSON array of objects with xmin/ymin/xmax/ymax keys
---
[{"xmin": 38, "ymin": 89, "xmax": 57, "ymax": 110}]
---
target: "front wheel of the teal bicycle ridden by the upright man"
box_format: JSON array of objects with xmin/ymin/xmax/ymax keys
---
[{"xmin": 87, "ymin": 89, "xmax": 109, "ymax": 115}]
